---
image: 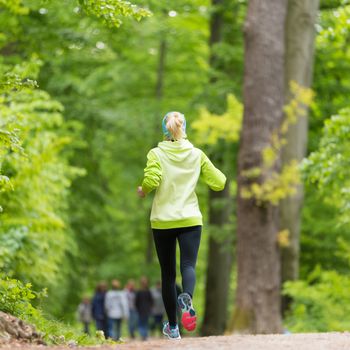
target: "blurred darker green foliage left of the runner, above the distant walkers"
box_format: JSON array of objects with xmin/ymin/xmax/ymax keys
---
[{"xmin": 32, "ymin": 1, "xmax": 211, "ymax": 314}]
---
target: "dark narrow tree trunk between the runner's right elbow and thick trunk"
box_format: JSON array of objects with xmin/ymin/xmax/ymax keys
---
[{"xmin": 201, "ymin": 0, "xmax": 233, "ymax": 336}]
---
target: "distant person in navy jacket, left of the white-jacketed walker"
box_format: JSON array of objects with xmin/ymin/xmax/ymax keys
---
[{"xmin": 91, "ymin": 282, "xmax": 109, "ymax": 338}]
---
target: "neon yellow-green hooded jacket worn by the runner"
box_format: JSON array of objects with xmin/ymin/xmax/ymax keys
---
[{"xmin": 142, "ymin": 140, "xmax": 226, "ymax": 229}]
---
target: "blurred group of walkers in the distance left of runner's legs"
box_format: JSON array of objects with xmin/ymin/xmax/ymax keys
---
[{"xmin": 78, "ymin": 277, "xmax": 165, "ymax": 340}]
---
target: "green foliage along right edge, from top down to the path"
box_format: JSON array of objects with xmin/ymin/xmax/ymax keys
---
[{"xmin": 292, "ymin": 18, "xmax": 350, "ymax": 326}]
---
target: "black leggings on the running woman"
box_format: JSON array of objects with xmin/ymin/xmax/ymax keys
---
[{"xmin": 153, "ymin": 226, "xmax": 202, "ymax": 326}]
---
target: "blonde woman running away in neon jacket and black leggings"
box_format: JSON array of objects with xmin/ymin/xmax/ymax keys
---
[{"xmin": 137, "ymin": 112, "xmax": 226, "ymax": 339}]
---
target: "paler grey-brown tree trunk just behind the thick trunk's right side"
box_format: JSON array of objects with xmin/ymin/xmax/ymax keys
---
[{"xmin": 280, "ymin": 0, "xmax": 319, "ymax": 311}]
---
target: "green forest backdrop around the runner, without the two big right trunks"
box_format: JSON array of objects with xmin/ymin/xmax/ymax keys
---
[{"xmin": 0, "ymin": 0, "xmax": 350, "ymax": 344}]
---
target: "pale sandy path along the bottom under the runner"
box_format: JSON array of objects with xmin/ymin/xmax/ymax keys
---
[{"xmin": 1, "ymin": 332, "xmax": 350, "ymax": 350}]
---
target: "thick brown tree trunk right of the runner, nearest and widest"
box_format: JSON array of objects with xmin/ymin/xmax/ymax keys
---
[{"xmin": 233, "ymin": 0, "xmax": 287, "ymax": 333}]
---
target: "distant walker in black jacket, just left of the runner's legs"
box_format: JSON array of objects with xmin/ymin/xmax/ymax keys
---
[{"xmin": 135, "ymin": 277, "xmax": 153, "ymax": 340}]
